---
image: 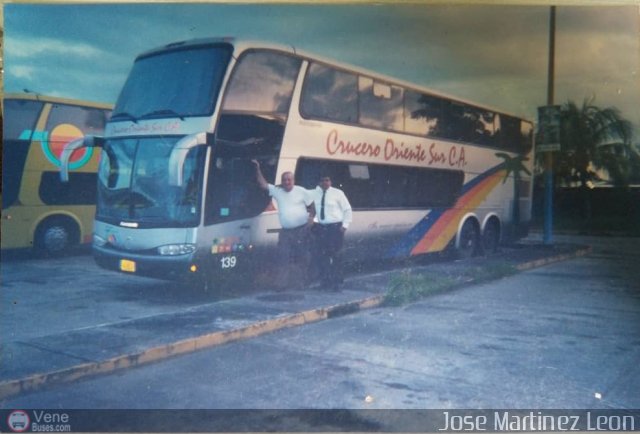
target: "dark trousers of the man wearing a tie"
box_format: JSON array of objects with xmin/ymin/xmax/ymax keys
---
[{"xmin": 313, "ymin": 223, "xmax": 344, "ymax": 285}]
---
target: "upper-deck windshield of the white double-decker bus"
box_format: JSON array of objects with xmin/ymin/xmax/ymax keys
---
[{"xmin": 112, "ymin": 45, "xmax": 231, "ymax": 121}]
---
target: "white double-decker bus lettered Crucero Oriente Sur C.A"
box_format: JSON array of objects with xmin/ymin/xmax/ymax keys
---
[{"xmin": 62, "ymin": 38, "xmax": 533, "ymax": 283}]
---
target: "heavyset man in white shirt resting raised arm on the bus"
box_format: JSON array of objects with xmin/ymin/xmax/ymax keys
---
[{"xmin": 251, "ymin": 160, "xmax": 316, "ymax": 286}]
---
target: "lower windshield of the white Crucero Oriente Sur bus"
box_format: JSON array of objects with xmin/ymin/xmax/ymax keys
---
[{"xmin": 96, "ymin": 137, "xmax": 205, "ymax": 227}]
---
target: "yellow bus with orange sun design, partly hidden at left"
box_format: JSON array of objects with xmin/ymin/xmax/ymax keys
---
[{"xmin": 0, "ymin": 93, "xmax": 112, "ymax": 254}]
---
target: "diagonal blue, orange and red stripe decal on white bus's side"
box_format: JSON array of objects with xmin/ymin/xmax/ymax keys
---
[{"xmin": 388, "ymin": 163, "xmax": 507, "ymax": 258}]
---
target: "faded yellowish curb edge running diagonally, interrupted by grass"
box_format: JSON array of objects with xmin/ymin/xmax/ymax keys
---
[{"xmin": 0, "ymin": 247, "xmax": 592, "ymax": 399}]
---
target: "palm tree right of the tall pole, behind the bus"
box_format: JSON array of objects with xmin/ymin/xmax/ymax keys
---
[{"xmin": 554, "ymin": 98, "xmax": 632, "ymax": 220}]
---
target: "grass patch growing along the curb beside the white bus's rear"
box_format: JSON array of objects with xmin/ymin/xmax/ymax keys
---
[{"xmin": 384, "ymin": 262, "xmax": 518, "ymax": 306}]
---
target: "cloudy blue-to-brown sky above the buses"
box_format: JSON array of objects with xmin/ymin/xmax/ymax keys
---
[{"xmin": 4, "ymin": 3, "xmax": 640, "ymax": 143}]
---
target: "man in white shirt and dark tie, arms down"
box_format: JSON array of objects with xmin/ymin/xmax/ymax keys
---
[{"xmin": 311, "ymin": 175, "xmax": 353, "ymax": 290}]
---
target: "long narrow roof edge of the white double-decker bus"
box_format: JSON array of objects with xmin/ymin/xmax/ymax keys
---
[{"xmin": 142, "ymin": 37, "xmax": 531, "ymax": 122}]
